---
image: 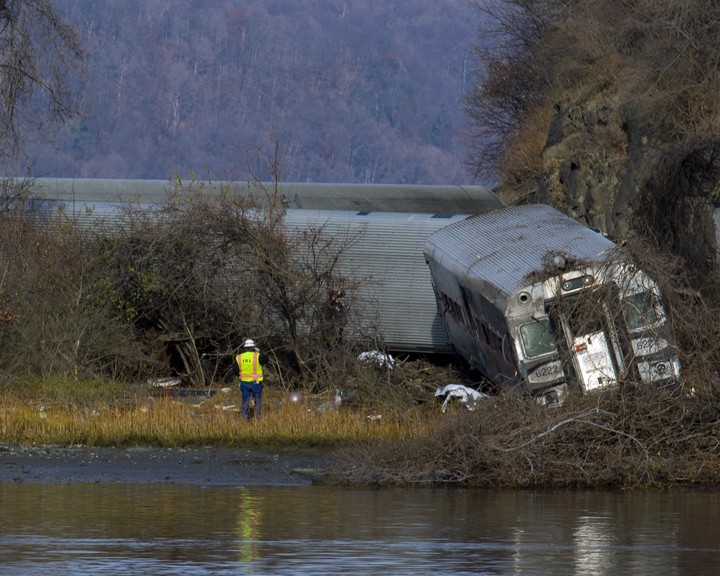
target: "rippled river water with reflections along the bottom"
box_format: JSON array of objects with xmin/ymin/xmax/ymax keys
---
[{"xmin": 0, "ymin": 483, "xmax": 720, "ymax": 576}]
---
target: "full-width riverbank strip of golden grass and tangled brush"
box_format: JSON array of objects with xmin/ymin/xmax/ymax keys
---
[{"xmin": 5, "ymin": 381, "xmax": 720, "ymax": 489}]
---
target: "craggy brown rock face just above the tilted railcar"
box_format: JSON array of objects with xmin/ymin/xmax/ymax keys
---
[{"xmin": 531, "ymin": 96, "xmax": 720, "ymax": 278}]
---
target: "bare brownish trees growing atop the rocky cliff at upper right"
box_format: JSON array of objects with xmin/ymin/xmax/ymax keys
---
[{"xmin": 466, "ymin": 0, "xmax": 720, "ymax": 194}]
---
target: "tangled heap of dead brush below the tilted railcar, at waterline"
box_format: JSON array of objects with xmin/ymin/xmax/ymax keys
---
[{"xmin": 336, "ymin": 385, "xmax": 720, "ymax": 488}]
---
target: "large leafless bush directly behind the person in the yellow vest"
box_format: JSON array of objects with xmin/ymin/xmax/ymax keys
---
[{"xmin": 90, "ymin": 173, "xmax": 360, "ymax": 385}]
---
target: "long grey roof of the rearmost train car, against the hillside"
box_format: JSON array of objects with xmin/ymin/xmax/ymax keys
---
[{"xmin": 23, "ymin": 178, "xmax": 504, "ymax": 214}]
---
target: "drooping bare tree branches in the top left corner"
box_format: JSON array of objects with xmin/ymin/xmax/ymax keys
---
[{"xmin": 0, "ymin": 0, "xmax": 84, "ymax": 156}]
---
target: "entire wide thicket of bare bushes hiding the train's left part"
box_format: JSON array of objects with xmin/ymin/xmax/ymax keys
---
[{"xmin": 0, "ymin": 172, "xmax": 442, "ymax": 409}]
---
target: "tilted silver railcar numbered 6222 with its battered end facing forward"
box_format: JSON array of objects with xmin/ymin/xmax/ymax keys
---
[{"xmin": 424, "ymin": 205, "xmax": 680, "ymax": 404}]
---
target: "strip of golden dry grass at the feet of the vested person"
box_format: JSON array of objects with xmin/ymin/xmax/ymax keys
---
[{"xmin": 0, "ymin": 382, "xmax": 437, "ymax": 447}]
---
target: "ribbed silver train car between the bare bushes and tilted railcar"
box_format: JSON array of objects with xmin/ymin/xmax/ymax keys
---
[{"xmin": 285, "ymin": 210, "xmax": 467, "ymax": 354}]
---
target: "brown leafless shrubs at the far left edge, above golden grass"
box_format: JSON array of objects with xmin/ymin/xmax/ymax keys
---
[{"xmin": 0, "ymin": 209, "xmax": 152, "ymax": 378}]
